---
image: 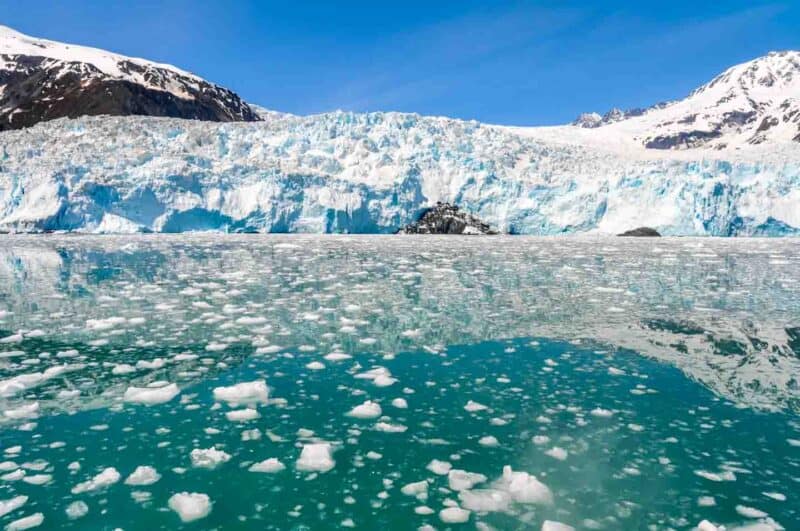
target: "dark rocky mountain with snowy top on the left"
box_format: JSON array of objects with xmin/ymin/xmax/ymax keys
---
[{"xmin": 0, "ymin": 26, "xmax": 258, "ymax": 131}]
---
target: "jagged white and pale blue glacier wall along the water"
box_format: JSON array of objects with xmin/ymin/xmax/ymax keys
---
[{"xmin": 0, "ymin": 112, "xmax": 800, "ymax": 236}]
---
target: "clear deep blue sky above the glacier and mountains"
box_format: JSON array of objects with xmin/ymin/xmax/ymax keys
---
[{"xmin": 0, "ymin": 0, "xmax": 800, "ymax": 125}]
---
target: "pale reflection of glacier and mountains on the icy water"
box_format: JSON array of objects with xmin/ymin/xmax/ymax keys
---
[{"xmin": 0, "ymin": 235, "xmax": 800, "ymax": 410}]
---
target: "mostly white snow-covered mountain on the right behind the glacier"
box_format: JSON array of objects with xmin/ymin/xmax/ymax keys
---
[{"xmin": 574, "ymin": 51, "xmax": 800, "ymax": 149}]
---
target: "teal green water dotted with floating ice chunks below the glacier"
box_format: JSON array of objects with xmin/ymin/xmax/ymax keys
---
[{"xmin": 0, "ymin": 235, "xmax": 800, "ymax": 530}]
